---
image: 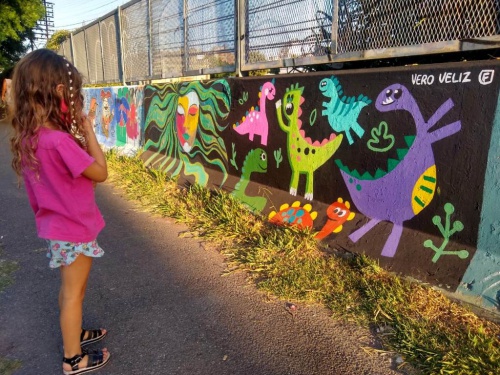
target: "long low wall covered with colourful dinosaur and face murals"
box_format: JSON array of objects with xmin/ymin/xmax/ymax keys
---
[{"xmin": 86, "ymin": 61, "xmax": 500, "ymax": 310}]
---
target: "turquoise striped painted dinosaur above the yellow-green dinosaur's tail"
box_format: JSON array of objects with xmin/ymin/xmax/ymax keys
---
[{"xmin": 319, "ymin": 76, "xmax": 372, "ymax": 145}]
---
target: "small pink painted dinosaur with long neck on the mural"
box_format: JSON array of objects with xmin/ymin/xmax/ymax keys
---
[{"xmin": 233, "ymin": 82, "xmax": 276, "ymax": 146}]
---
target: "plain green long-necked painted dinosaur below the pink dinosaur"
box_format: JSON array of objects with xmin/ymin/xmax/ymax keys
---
[{"xmin": 232, "ymin": 148, "xmax": 267, "ymax": 212}]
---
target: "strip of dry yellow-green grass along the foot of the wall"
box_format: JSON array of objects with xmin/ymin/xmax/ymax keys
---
[{"xmin": 107, "ymin": 152, "xmax": 500, "ymax": 375}]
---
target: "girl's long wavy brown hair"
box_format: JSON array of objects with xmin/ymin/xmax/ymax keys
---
[{"xmin": 10, "ymin": 49, "xmax": 85, "ymax": 176}]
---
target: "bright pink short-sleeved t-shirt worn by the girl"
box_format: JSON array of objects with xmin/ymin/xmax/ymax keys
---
[{"xmin": 24, "ymin": 128, "xmax": 104, "ymax": 242}]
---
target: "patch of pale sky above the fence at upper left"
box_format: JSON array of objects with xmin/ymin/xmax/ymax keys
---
[{"xmin": 49, "ymin": 0, "xmax": 129, "ymax": 30}]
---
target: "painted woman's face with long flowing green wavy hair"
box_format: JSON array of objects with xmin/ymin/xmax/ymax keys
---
[{"xmin": 144, "ymin": 80, "xmax": 231, "ymax": 186}]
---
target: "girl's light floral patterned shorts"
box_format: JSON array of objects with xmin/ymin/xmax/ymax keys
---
[{"xmin": 47, "ymin": 240, "xmax": 104, "ymax": 268}]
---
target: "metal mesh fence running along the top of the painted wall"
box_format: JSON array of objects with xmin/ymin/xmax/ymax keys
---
[{"xmin": 59, "ymin": 0, "xmax": 500, "ymax": 83}]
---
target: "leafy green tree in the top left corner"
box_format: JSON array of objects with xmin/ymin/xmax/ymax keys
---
[{"xmin": 0, "ymin": 0, "xmax": 45, "ymax": 71}]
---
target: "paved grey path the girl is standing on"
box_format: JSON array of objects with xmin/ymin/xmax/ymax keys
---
[{"xmin": 0, "ymin": 123, "xmax": 414, "ymax": 375}]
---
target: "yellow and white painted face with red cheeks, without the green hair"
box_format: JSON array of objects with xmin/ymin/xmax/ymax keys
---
[{"xmin": 176, "ymin": 91, "xmax": 200, "ymax": 153}]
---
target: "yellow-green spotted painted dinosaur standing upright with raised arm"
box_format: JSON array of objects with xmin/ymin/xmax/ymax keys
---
[{"xmin": 276, "ymin": 83, "xmax": 343, "ymax": 200}]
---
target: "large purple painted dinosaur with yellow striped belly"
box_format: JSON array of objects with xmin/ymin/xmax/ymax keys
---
[{"xmin": 336, "ymin": 84, "xmax": 461, "ymax": 257}]
